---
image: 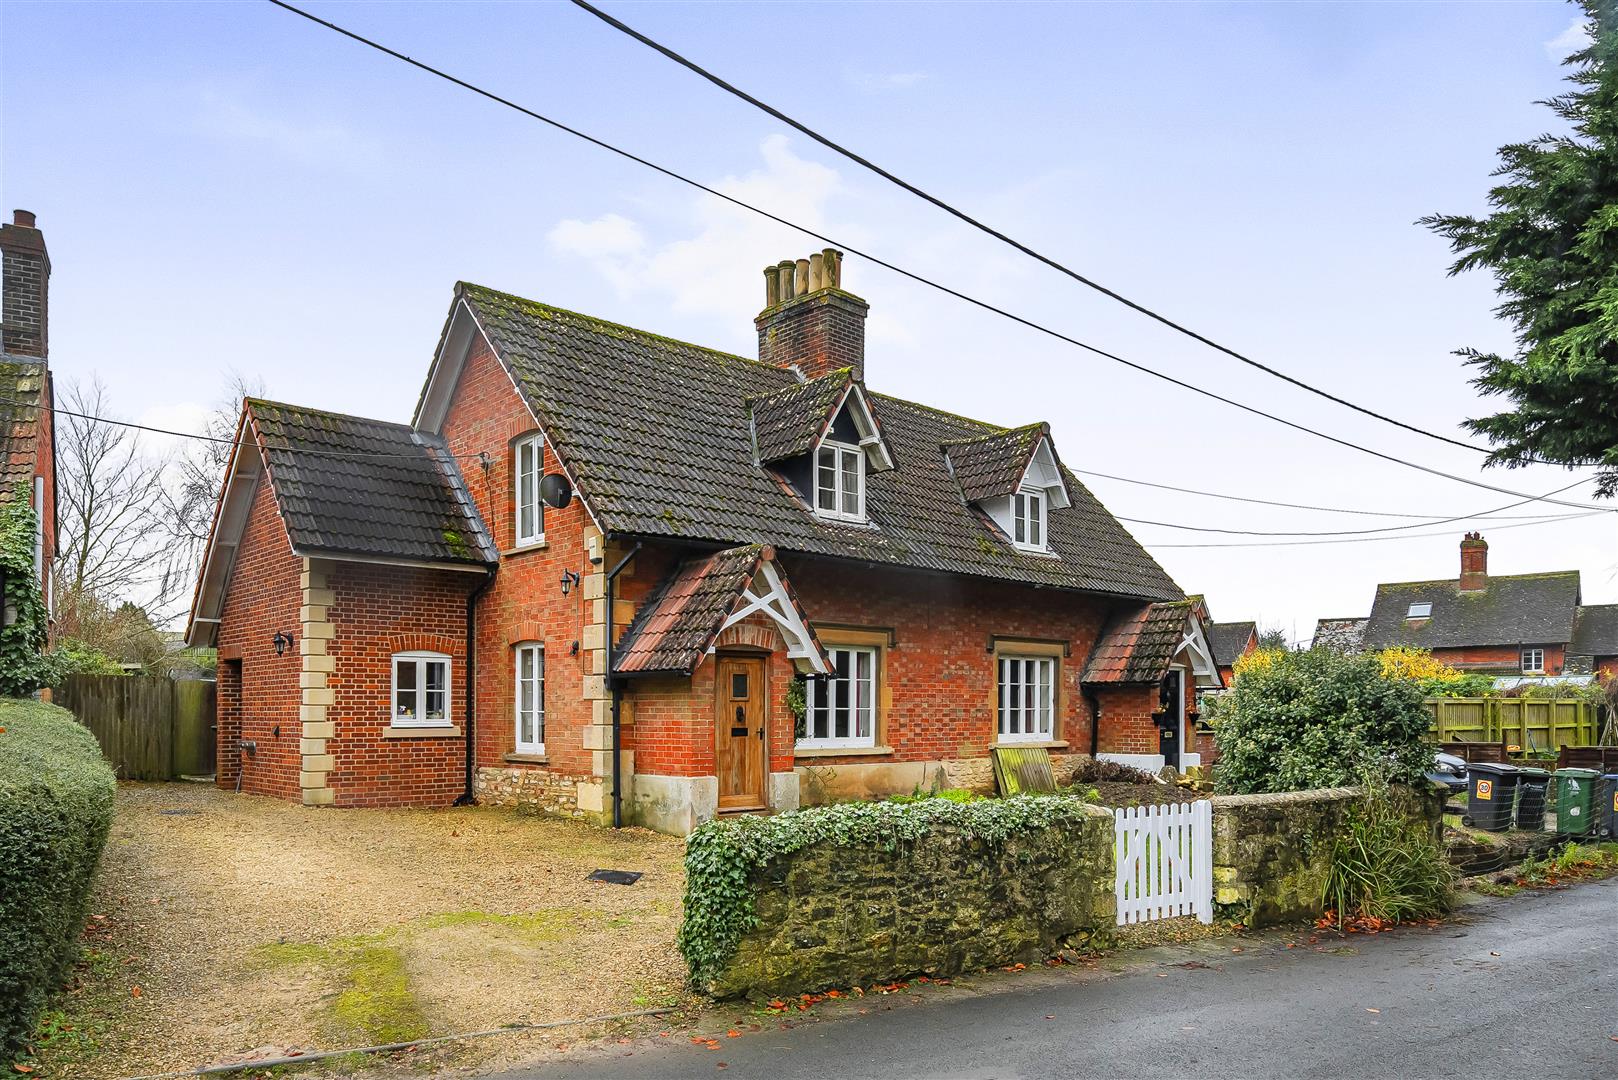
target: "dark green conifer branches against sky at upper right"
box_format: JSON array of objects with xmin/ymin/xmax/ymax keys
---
[{"xmin": 1421, "ymin": 0, "xmax": 1618, "ymax": 495}]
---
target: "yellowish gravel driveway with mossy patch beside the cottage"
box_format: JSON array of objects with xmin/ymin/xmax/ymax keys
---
[{"xmin": 42, "ymin": 784, "xmax": 684, "ymax": 1077}]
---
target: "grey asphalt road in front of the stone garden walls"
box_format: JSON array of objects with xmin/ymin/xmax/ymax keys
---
[{"xmin": 506, "ymin": 881, "xmax": 1618, "ymax": 1080}]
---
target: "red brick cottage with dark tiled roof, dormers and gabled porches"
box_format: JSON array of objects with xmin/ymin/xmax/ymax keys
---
[{"xmin": 188, "ymin": 251, "xmax": 1218, "ymax": 832}]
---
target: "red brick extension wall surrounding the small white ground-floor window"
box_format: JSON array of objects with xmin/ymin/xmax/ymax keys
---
[{"xmin": 324, "ymin": 562, "xmax": 482, "ymax": 806}]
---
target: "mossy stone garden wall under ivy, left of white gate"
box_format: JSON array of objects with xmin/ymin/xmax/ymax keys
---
[{"xmin": 710, "ymin": 806, "xmax": 1115, "ymax": 997}]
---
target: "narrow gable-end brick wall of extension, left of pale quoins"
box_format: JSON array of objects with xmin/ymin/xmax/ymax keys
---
[{"xmin": 217, "ymin": 479, "xmax": 303, "ymax": 798}]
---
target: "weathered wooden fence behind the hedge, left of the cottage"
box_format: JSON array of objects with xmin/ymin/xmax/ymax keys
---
[{"xmin": 52, "ymin": 675, "xmax": 215, "ymax": 780}]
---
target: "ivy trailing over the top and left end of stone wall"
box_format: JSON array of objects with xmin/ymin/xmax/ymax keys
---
[{"xmin": 676, "ymin": 795, "xmax": 1086, "ymax": 988}]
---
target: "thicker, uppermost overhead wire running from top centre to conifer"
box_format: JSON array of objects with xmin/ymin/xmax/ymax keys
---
[{"xmin": 573, "ymin": 0, "xmax": 1490, "ymax": 453}]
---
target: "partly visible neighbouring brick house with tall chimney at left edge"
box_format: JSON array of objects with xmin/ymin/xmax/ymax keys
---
[{"xmin": 0, "ymin": 210, "xmax": 57, "ymax": 610}]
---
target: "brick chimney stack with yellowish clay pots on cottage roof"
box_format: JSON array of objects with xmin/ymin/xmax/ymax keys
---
[{"xmin": 754, "ymin": 248, "xmax": 870, "ymax": 386}]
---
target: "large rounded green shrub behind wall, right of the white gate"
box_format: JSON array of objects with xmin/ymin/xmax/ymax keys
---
[{"xmin": 1214, "ymin": 649, "xmax": 1432, "ymax": 793}]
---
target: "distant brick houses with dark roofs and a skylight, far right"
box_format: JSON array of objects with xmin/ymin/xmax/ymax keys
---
[{"xmin": 1314, "ymin": 533, "xmax": 1618, "ymax": 678}]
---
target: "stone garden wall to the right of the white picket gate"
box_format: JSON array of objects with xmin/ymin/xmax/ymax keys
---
[{"xmin": 1214, "ymin": 787, "xmax": 1445, "ymax": 926}]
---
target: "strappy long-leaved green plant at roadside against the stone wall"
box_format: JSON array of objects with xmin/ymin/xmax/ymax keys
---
[{"xmin": 1324, "ymin": 779, "xmax": 1455, "ymax": 925}]
